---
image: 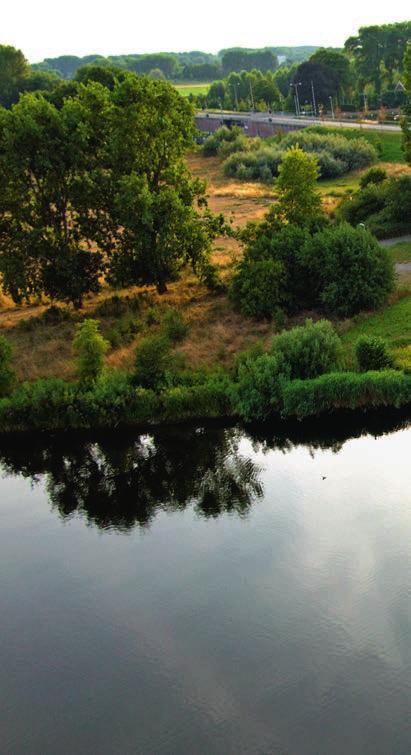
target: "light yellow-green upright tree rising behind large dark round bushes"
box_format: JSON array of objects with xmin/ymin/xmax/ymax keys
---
[{"xmin": 275, "ymin": 146, "xmax": 322, "ymax": 227}]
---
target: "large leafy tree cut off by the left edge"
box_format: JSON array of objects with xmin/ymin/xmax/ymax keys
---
[{"xmin": 0, "ymin": 84, "xmax": 109, "ymax": 306}]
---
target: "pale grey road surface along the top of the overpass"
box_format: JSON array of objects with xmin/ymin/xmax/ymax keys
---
[{"xmin": 197, "ymin": 110, "xmax": 401, "ymax": 133}]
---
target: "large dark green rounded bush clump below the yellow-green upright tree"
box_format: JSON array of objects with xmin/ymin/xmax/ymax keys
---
[{"xmin": 231, "ymin": 224, "xmax": 394, "ymax": 318}]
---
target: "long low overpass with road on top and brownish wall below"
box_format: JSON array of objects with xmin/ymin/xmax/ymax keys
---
[{"xmin": 195, "ymin": 110, "xmax": 401, "ymax": 138}]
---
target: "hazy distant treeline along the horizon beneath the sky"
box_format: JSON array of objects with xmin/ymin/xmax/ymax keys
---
[{"xmin": 32, "ymin": 46, "xmax": 317, "ymax": 81}]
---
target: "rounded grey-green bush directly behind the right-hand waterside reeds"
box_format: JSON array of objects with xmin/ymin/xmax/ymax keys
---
[{"xmin": 272, "ymin": 320, "xmax": 341, "ymax": 380}]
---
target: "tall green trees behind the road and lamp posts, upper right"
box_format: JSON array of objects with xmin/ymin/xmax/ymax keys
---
[{"xmin": 196, "ymin": 21, "xmax": 411, "ymax": 112}]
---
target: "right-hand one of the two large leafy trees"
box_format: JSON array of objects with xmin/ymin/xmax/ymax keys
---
[{"xmin": 100, "ymin": 77, "xmax": 223, "ymax": 293}]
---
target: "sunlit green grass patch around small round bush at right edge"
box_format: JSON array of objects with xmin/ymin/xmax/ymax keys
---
[{"xmin": 342, "ymin": 293, "xmax": 411, "ymax": 369}]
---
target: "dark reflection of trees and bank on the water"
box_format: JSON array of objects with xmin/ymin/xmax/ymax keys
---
[{"xmin": 0, "ymin": 412, "xmax": 407, "ymax": 531}]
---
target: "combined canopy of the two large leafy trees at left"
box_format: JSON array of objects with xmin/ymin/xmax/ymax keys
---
[{"xmin": 0, "ymin": 74, "xmax": 222, "ymax": 306}]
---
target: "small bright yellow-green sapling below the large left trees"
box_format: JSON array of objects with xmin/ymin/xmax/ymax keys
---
[{"xmin": 73, "ymin": 319, "xmax": 110, "ymax": 381}]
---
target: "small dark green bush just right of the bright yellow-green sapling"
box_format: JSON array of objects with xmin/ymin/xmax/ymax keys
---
[{"xmin": 133, "ymin": 336, "xmax": 171, "ymax": 389}]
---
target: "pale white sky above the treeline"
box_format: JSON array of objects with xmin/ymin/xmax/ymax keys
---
[{"xmin": 4, "ymin": 0, "xmax": 411, "ymax": 63}]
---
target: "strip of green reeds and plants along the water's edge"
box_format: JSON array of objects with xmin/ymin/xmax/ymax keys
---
[{"xmin": 0, "ymin": 370, "xmax": 411, "ymax": 433}]
